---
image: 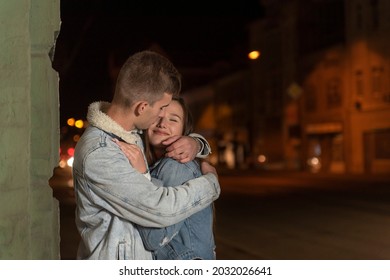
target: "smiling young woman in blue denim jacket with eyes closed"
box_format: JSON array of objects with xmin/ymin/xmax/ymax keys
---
[{"xmin": 120, "ymin": 97, "xmax": 215, "ymax": 260}]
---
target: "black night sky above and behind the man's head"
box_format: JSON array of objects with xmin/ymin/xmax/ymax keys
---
[{"xmin": 53, "ymin": 0, "xmax": 263, "ymax": 125}]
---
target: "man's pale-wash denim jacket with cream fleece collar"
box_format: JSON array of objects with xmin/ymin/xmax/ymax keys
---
[{"xmin": 73, "ymin": 102, "xmax": 220, "ymax": 259}]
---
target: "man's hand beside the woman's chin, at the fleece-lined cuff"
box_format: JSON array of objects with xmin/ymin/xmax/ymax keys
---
[{"xmin": 162, "ymin": 136, "xmax": 200, "ymax": 163}]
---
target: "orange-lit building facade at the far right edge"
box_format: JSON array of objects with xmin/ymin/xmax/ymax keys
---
[{"xmin": 345, "ymin": 0, "xmax": 390, "ymax": 173}]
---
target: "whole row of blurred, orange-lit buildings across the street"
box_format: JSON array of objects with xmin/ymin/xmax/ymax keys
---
[{"xmin": 185, "ymin": 0, "xmax": 390, "ymax": 173}]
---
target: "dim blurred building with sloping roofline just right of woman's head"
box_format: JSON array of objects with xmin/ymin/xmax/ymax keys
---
[{"xmin": 183, "ymin": 70, "xmax": 252, "ymax": 169}]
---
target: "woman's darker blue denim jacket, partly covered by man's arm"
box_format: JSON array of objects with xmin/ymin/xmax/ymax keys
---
[{"xmin": 139, "ymin": 158, "xmax": 215, "ymax": 260}]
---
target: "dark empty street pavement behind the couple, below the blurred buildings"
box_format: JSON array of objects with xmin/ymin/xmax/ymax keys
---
[{"xmin": 51, "ymin": 167, "xmax": 390, "ymax": 260}]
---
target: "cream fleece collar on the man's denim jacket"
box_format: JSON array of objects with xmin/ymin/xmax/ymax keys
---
[{"xmin": 87, "ymin": 101, "xmax": 140, "ymax": 144}]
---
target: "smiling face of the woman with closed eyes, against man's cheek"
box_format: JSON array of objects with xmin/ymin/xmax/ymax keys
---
[{"xmin": 148, "ymin": 100, "xmax": 184, "ymax": 147}]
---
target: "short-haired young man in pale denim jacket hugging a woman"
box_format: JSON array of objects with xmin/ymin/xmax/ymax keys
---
[{"xmin": 73, "ymin": 51, "xmax": 220, "ymax": 259}]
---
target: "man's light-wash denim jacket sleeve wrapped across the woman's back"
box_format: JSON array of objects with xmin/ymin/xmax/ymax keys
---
[{"xmin": 74, "ymin": 141, "xmax": 220, "ymax": 227}]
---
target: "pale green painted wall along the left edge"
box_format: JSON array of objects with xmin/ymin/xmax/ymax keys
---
[{"xmin": 0, "ymin": 0, "xmax": 60, "ymax": 259}]
